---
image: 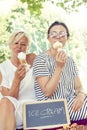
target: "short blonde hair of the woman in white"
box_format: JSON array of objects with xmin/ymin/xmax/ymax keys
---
[{"xmin": 9, "ymin": 31, "xmax": 30, "ymax": 45}]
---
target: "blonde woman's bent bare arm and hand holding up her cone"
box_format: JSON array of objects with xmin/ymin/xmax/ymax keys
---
[{"xmin": 1, "ymin": 65, "xmax": 26, "ymax": 98}]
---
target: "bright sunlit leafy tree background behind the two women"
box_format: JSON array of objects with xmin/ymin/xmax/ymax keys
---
[{"xmin": 0, "ymin": 0, "xmax": 87, "ymax": 89}]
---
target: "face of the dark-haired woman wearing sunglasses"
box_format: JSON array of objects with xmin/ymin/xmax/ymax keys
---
[{"xmin": 48, "ymin": 25, "xmax": 68, "ymax": 46}]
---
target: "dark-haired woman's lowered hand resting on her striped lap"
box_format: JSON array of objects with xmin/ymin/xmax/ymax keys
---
[{"xmin": 72, "ymin": 93, "xmax": 85, "ymax": 111}]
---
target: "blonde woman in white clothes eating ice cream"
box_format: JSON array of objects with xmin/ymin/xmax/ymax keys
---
[{"xmin": 0, "ymin": 31, "xmax": 36, "ymax": 130}]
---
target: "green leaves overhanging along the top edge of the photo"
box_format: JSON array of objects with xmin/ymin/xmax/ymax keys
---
[{"xmin": 20, "ymin": 0, "xmax": 87, "ymax": 15}]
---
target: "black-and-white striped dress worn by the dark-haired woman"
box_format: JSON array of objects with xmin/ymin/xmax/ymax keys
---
[{"xmin": 33, "ymin": 53, "xmax": 87, "ymax": 120}]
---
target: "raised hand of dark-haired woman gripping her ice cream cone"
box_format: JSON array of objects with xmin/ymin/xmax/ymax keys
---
[{"xmin": 56, "ymin": 49, "xmax": 67, "ymax": 68}]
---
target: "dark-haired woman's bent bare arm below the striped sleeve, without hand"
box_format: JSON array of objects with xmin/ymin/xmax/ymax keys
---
[{"xmin": 37, "ymin": 67, "xmax": 61, "ymax": 97}]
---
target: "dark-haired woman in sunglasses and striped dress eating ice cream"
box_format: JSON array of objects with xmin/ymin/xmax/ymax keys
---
[{"xmin": 33, "ymin": 21, "xmax": 87, "ymax": 121}]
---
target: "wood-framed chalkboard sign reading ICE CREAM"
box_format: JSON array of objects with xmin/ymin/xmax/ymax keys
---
[{"xmin": 23, "ymin": 99, "xmax": 70, "ymax": 129}]
